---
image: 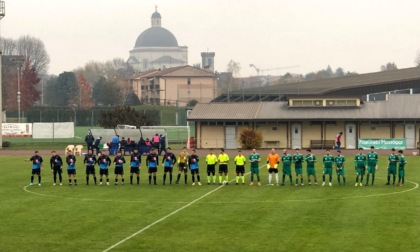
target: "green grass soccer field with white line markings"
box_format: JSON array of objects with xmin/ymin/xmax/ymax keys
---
[{"xmin": 0, "ymin": 156, "xmax": 420, "ymax": 252}]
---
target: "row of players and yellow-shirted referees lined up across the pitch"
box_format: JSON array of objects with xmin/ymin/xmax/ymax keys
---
[{"xmin": 28, "ymin": 146, "xmax": 406, "ymax": 186}]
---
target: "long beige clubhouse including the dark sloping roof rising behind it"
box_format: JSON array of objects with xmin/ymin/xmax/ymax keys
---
[{"xmin": 188, "ymin": 67, "xmax": 420, "ymax": 149}]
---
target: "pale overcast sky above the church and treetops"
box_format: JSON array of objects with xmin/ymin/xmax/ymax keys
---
[{"xmin": 1, "ymin": 0, "xmax": 420, "ymax": 76}]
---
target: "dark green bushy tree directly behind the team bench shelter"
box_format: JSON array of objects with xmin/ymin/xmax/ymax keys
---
[{"xmin": 98, "ymin": 106, "xmax": 157, "ymax": 129}]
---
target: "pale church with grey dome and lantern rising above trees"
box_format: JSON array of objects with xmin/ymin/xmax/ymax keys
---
[{"xmin": 127, "ymin": 8, "xmax": 188, "ymax": 72}]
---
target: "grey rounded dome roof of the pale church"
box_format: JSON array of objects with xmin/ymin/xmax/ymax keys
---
[{"xmin": 135, "ymin": 26, "xmax": 178, "ymax": 47}]
